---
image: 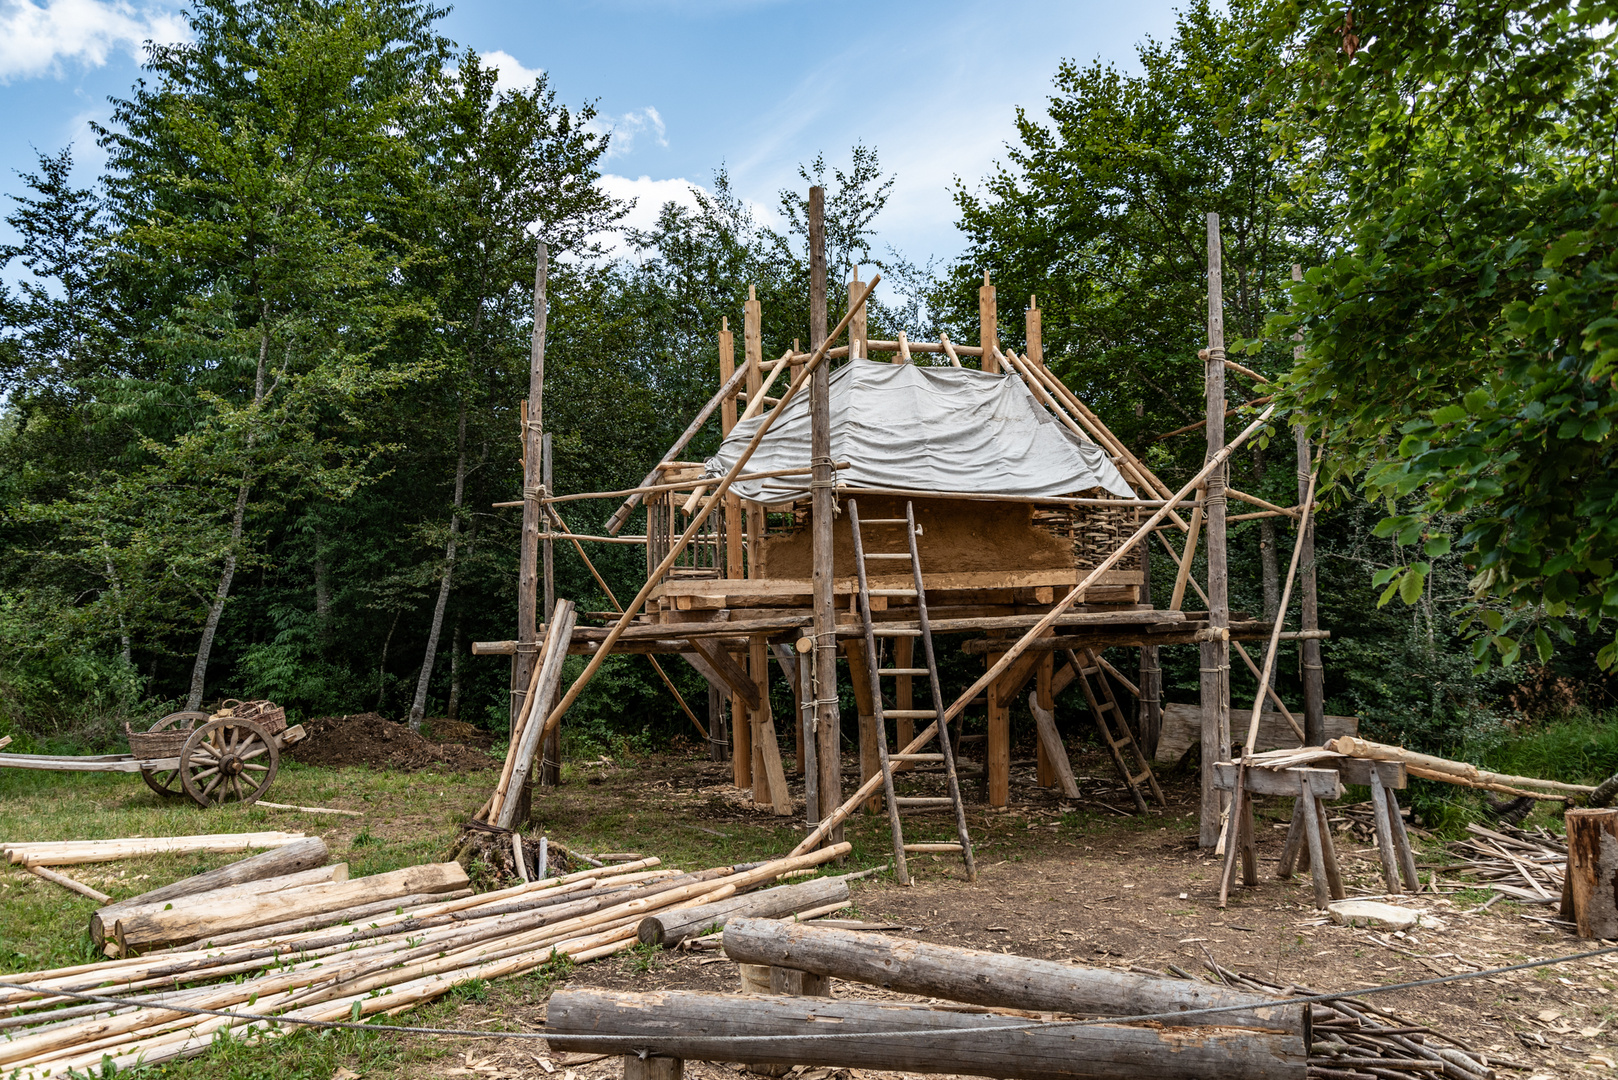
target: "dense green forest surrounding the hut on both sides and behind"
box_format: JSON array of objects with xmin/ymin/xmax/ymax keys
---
[{"xmin": 0, "ymin": 0, "xmax": 1618, "ymax": 793}]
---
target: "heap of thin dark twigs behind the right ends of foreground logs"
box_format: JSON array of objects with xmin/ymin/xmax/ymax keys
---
[{"xmin": 1190, "ymin": 960, "xmax": 1501, "ymax": 1080}]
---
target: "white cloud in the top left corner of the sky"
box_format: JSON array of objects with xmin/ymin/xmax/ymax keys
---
[{"xmin": 0, "ymin": 0, "xmax": 191, "ymax": 83}]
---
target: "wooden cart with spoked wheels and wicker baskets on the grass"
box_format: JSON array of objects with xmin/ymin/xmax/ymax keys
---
[{"xmin": 0, "ymin": 701, "xmax": 304, "ymax": 808}]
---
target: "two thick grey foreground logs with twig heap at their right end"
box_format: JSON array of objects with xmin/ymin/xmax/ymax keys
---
[{"xmin": 545, "ymin": 918, "xmax": 1511, "ymax": 1080}]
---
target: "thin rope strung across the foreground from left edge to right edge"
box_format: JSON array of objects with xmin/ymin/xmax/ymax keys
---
[{"xmin": 0, "ymin": 946, "xmax": 1618, "ymax": 1057}]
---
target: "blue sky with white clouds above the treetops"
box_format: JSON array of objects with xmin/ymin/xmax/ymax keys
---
[{"xmin": 0, "ymin": 0, "xmax": 1175, "ymax": 268}]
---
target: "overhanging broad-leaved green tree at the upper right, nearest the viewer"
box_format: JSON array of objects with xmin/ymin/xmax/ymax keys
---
[{"xmin": 1272, "ymin": 0, "xmax": 1618, "ymax": 667}]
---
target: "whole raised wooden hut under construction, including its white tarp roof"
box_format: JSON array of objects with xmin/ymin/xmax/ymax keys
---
[{"xmin": 476, "ymin": 189, "xmax": 1324, "ymax": 878}]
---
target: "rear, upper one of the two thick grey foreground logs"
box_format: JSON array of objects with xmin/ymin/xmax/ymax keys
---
[{"xmin": 725, "ymin": 918, "xmax": 1309, "ymax": 1036}]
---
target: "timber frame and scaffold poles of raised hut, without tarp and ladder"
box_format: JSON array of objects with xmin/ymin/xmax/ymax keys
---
[{"xmin": 472, "ymin": 200, "xmax": 1328, "ymax": 852}]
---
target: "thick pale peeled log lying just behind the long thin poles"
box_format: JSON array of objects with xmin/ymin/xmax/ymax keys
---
[{"xmin": 113, "ymin": 863, "xmax": 468, "ymax": 950}]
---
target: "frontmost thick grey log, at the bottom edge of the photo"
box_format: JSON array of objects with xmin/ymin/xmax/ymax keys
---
[{"xmin": 545, "ymin": 989, "xmax": 1307, "ymax": 1080}]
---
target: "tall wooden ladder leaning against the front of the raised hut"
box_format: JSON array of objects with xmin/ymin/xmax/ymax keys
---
[{"xmin": 848, "ymin": 499, "xmax": 977, "ymax": 886}]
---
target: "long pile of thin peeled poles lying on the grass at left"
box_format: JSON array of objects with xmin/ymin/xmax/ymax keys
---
[{"xmin": 0, "ymin": 844, "xmax": 849, "ymax": 1080}]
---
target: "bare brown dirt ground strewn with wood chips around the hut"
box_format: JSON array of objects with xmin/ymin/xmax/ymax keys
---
[{"xmin": 360, "ymin": 756, "xmax": 1618, "ymax": 1080}]
